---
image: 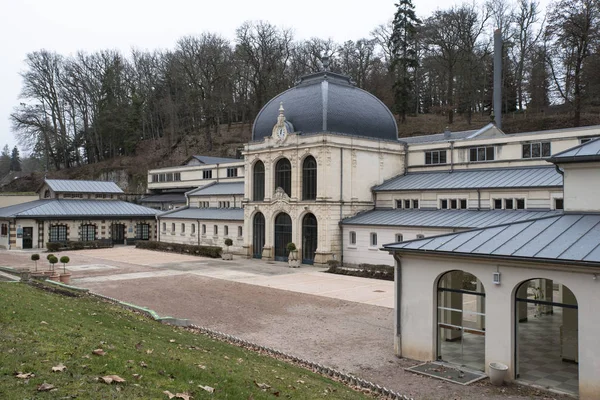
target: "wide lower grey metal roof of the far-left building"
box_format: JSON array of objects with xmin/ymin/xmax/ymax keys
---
[{"xmin": 0, "ymin": 199, "xmax": 158, "ymax": 219}]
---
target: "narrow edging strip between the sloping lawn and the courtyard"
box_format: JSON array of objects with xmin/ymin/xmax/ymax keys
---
[{"xmin": 37, "ymin": 281, "xmax": 414, "ymax": 400}]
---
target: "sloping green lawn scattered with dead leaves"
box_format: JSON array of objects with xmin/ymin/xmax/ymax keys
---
[{"xmin": 0, "ymin": 283, "xmax": 365, "ymax": 400}]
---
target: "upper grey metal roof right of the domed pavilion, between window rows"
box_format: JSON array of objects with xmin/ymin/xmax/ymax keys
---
[{"xmin": 373, "ymin": 166, "xmax": 563, "ymax": 192}]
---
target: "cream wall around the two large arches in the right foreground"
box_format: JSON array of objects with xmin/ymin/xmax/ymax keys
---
[{"xmin": 395, "ymin": 254, "xmax": 600, "ymax": 399}]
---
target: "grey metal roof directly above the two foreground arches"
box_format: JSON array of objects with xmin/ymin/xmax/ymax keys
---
[{"xmin": 383, "ymin": 214, "xmax": 600, "ymax": 264}]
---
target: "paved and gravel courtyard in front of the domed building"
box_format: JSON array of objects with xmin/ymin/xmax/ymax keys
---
[{"xmin": 0, "ymin": 247, "xmax": 572, "ymax": 399}]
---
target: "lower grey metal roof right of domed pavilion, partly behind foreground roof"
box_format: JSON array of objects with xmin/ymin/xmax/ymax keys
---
[{"xmin": 342, "ymin": 209, "xmax": 562, "ymax": 228}]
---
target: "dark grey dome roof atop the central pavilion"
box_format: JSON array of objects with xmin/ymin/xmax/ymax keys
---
[{"xmin": 252, "ymin": 71, "xmax": 398, "ymax": 140}]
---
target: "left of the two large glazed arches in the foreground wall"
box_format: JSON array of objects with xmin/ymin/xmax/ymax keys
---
[{"xmin": 437, "ymin": 271, "xmax": 485, "ymax": 371}]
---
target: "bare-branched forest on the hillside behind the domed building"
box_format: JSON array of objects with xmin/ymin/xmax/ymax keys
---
[{"xmin": 5, "ymin": 0, "xmax": 600, "ymax": 171}]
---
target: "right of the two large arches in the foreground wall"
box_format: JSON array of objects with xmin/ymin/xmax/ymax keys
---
[{"xmin": 515, "ymin": 278, "xmax": 579, "ymax": 394}]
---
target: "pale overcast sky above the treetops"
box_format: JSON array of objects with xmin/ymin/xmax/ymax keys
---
[{"xmin": 0, "ymin": 0, "xmax": 516, "ymax": 153}]
